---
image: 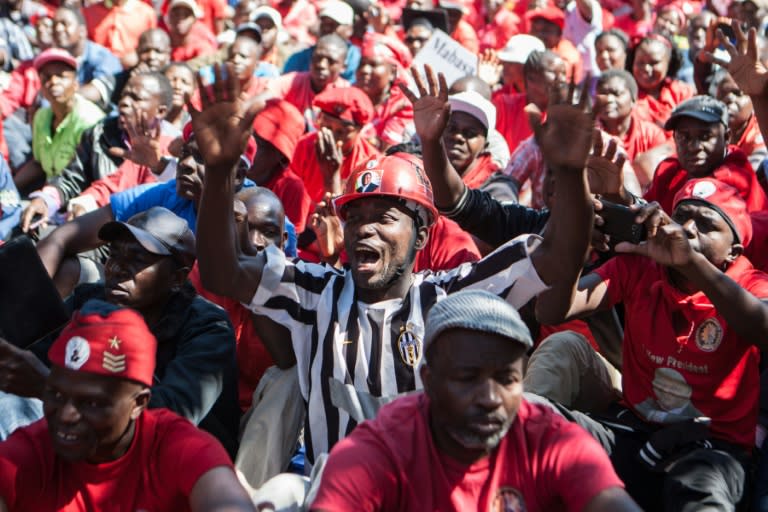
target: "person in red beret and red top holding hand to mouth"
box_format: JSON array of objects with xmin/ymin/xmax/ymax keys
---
[{"xmin": 291, "ymin": 87, "xmax": 379, "ymax": 203}]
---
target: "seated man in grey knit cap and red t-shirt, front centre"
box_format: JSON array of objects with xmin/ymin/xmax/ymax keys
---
[{"xmin": 311, "ymin": 290, "xmax": 640, "ymax": 512}]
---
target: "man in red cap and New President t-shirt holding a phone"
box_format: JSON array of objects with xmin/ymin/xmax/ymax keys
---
[{"xmin": 526, "ymin": 178, "xmax": 768, "ymax": 510}]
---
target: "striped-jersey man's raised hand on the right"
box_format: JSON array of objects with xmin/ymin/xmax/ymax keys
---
[{"xmin": 525, "ymin": 78, "xmax": 595, "ymax": 172}]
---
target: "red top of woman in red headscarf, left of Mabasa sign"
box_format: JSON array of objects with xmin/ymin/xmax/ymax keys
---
[{"xmin": 363, "ymin": 80, "xmax": 416, "ymax": 148}]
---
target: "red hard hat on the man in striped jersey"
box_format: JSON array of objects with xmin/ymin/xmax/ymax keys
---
[{"xmin": 333, "ymin": 153, "xmax": 437, "ymax": 226}]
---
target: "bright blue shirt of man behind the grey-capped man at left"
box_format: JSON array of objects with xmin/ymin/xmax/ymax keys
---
[{"xmin": 111, "ymin": 178, "xmax": 296, "ymax": 258}]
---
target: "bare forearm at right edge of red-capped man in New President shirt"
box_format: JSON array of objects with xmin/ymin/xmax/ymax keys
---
[{"xmin": 677, "ymin": 253, "xmax": 768, "ymax": 350}]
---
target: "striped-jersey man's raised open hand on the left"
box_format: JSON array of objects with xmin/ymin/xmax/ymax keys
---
[{"xmin": 187, "ymin": 63, "xmax": 264, "ymax": 172}]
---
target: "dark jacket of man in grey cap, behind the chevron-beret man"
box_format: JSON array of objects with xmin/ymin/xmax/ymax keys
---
[{"xmin": 33, "ymin": 283, "xmax": 240, "ymax": 457}]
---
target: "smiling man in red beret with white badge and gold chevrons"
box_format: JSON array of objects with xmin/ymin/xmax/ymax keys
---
[{"xmin": 0, "ymin": 300, "xmax": 254, "ymax": 512}]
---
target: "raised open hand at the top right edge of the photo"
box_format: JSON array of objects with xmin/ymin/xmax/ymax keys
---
[{"xmin": 706, "ymin": 21, "xmax": 768, "ymax": 96}]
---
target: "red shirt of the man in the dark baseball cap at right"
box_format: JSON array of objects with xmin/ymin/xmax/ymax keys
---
[{"xmin": 644, "ymin": 146, "xmax": 768, "ymax": 214}]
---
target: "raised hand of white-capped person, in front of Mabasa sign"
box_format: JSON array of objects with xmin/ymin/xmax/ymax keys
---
[{"xmin": 398, "ymin": 65, "xmax": 451, "ymax": 141}]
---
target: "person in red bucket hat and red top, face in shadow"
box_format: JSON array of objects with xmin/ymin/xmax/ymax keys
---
[{"xmin": 248, "ymin": 99, "xmax": 312, "ymax": 234}]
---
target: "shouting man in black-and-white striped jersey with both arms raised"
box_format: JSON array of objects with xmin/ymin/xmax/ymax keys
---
[{"xmin": 190, "ymin": 63, "xmax": 594, "ymax": 463}]
